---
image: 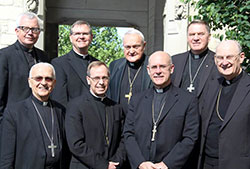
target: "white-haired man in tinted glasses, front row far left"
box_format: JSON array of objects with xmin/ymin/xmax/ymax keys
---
[{"xmin": 0, "ymin": 62, "xmax": 67, "ymax": 169}]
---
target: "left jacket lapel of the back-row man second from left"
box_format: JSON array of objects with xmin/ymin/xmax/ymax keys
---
[{"xmin": 68, "ymin": 50, "xmax": 88, "ymax": 87}]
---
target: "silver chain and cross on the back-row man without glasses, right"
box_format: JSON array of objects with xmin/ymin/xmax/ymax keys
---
[{"xmin": 187, "ymin": 54, "xmax": 208, "ymax": 93}]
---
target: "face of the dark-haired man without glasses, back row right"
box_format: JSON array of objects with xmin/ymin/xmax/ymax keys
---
[{"xmin": 187, "ymin": 23, "xmax": 210, "ymax": 55}]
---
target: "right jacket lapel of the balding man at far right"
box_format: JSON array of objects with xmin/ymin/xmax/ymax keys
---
[{"xmin": 220, "ymin": 72, "xmax": 250, "ymax": 131}]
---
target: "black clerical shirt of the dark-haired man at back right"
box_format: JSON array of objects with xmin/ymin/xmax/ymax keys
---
[{"xmin": 181, "ymin": 48, "xmax": 208, "ymax": 95}]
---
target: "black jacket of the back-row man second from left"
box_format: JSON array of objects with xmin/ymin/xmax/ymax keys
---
[{"xmin": 51, "ymin": 50, "xmax": 97, "ymax": 106}]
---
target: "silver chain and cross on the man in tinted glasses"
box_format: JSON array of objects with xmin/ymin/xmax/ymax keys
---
[{"xmin": 32, "ymin": 100, "xmax": 57, "ymax": 157}]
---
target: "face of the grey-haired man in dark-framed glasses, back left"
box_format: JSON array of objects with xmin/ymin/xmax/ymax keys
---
[{"xmin": 15, "ymin": 15, "xmax": 40, "ymax": 48}]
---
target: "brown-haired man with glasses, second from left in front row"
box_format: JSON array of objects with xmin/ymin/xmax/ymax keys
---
[{"xmin": 65, "ymin": 61, "xmax": 126, "ymax": 169}]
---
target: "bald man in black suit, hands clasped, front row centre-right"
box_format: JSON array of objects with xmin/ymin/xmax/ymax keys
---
[{"xmin": 124, "ymin": 51, "xmax": 199, "ymax": 169}]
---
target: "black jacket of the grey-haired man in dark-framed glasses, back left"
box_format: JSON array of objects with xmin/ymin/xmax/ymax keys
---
[{"xmin": 0, "ymin": 41, "xmax": 49, "ymax": 121}]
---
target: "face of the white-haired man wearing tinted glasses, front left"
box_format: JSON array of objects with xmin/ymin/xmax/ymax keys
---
[{"xmin": 28, "ymin": 65, "xmax": 56, "ymax": 101}]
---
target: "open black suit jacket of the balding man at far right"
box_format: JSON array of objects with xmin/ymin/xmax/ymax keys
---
[{"xmin": 198, "ymin": 72, "xmax": 250, "ymax": 169}]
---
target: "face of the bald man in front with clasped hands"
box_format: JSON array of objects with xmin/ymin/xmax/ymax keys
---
[{"xmin": 147, "ymin": 51, "xmax": 174, "ymax": 88}]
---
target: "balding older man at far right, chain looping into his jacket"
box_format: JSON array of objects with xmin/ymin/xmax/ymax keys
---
[{"xmin": 198, "ymin": 40, "xmax": 250, "ymax": 169}]
